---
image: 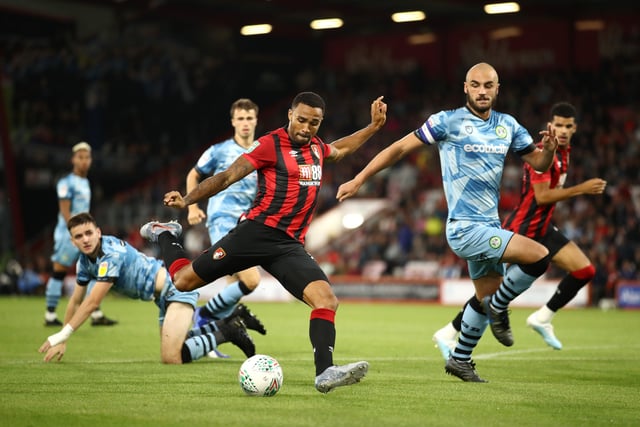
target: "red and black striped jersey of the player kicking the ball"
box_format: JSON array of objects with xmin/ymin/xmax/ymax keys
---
[{"xmin": 243, "ymin": 128, "xmax": 331, "ymax": 244}]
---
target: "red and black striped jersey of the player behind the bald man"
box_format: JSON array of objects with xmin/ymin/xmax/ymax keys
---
[{"xmin": 502, "ymin": 147, "xmax": 571, "ymax": 239}]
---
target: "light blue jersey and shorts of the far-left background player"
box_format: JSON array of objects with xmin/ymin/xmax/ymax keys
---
[{"xmin": 51, "ymin": 173, "xmax": 91, "ymax": 267}]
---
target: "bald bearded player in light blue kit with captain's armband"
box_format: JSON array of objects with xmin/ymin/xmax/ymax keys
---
[{"xmin": 337, "ymin": 63, "xmax": 558, "ymax": 382}]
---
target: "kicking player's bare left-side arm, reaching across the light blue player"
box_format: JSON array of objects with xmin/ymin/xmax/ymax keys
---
[{"xmin": 164, "ymin": 156, "xmax": 255, "ymax": 209}]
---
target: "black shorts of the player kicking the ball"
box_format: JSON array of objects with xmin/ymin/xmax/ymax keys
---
[{"xmin": 192, "ymin": 220, "xmax": 329, "ymax": 301}]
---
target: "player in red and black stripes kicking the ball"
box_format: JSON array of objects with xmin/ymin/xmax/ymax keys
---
[{"xmin": 140, "ymin": 92, "xmax": 387, "ymax": 393}]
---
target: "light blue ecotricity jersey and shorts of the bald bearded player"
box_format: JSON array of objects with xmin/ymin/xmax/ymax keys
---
[{"xmin": 415, "ymin": 107, "xmax": 535, "ymax": 279}]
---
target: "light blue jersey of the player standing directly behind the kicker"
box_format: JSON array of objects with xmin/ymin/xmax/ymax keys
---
[{"xmin": 195, "ymin": 138, "xmax": 258, "ymax": 244}]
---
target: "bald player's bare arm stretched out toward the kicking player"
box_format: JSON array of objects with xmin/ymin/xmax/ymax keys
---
[{"xmin": 336, "ymin": 132, "xmax": 423, "ymax": 201}]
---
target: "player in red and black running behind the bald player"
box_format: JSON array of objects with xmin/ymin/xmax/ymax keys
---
[{"xmin": 433, "ymin": 102, "xmax": 607, "ymax": 359}]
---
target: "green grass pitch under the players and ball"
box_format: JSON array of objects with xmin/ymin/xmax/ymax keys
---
[{"xmin": 0, "ymin": 297, "xmax": 640, "ymax": 427}]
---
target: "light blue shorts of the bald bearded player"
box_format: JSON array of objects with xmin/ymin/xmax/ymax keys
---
[{"xmin": 446, "ymin": 220, "xmax": 514, "ymax": 279}]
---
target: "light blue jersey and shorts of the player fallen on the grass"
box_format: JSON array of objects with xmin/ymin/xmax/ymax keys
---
[{"xmin": 76, "ymin": 235, "xmax": 199, "ymax": 325}]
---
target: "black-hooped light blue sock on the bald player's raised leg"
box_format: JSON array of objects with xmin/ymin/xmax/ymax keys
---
[{"xmin": 490, "ymin": 255, "xmax": 549, "ymax": 312}]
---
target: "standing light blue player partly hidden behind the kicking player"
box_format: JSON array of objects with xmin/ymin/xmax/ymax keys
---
[{"xmin": 187, "ymin": 98, "xmax": 267, "ymax": 357}]
